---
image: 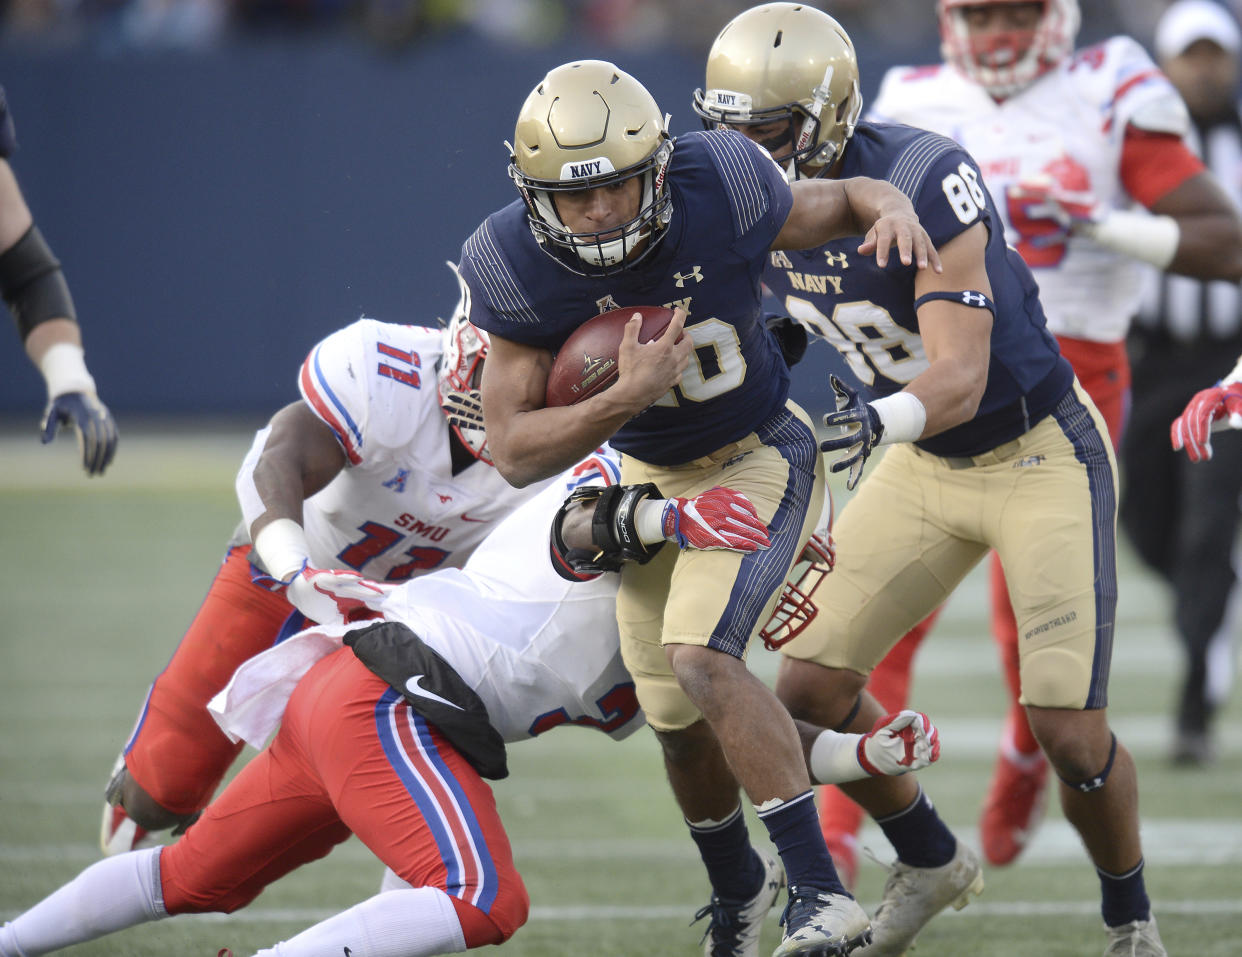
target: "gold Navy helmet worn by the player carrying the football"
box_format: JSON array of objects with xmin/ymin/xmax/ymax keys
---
[{"xmin": 509, "ymin": 60, "xmax": 673, "ymax": 276}]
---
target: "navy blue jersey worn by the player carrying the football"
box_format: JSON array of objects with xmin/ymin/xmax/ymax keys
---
[{"xmin": 461, "ymin": 130, "xmax": 792, "ymax": 465}]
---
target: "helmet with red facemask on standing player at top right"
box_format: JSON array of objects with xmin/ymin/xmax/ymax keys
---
[{"xmin": 938, "ymin": 0, "xmax": 1082, "ymax": 99}]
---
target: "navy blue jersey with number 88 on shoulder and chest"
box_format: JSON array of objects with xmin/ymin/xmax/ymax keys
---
[{"xmin": 764, "ymin": 124, "xmax": 1073, "ymax": 456}]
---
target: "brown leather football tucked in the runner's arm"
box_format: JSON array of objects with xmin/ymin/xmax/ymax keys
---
[{"xmin": 545, "ymin": 305, "xmax": 673, "ymax": 406}]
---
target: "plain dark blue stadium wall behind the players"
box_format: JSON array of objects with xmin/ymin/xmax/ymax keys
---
[{"xmin": 0, "ymin": 32, "xmax": 934, "ymax": 417}]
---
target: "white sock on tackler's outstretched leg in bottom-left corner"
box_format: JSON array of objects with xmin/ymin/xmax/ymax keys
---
[{"xmin": 0, "ymin": 848, "xmax": 168, "ymax": 957}]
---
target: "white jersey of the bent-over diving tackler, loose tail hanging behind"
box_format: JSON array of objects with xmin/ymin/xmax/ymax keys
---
[{"xmin": 209, "ymin": 449, "xmax": 645, "ymax": 747}]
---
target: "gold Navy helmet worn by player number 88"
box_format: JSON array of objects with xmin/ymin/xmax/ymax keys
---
[{"xmin": 694, "ymin": 4, "xmax": 862, "ymax": 180}]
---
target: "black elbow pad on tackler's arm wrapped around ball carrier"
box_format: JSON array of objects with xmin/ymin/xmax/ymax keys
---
[{"xmin": 549, "ymin": 482, "xmax": 664, "ymax": 581}]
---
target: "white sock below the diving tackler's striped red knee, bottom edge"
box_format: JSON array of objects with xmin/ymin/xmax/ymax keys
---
[{"xmin": 255, "ymin": 887, "xmax": 466, "ymax": 957}]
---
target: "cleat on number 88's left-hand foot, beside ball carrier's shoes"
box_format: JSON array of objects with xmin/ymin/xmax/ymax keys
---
[{"xmin": 858, "ymin": 840, "xmax": 984, "ymax": 957}]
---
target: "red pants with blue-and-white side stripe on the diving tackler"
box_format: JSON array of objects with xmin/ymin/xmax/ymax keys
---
[{"xmin": 160, "ymin": 648, "xmax": 529, "ymax": 947}]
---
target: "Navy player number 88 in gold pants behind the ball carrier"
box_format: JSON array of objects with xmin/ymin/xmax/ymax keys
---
[{"xmin": 696, "ymin": 2, "xmax": 1202, "ymax": 957}]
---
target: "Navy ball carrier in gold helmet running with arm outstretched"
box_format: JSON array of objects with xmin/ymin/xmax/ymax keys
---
[{"xmin": 460, "ymin": 61, "xmax": 939, "ymax": 957}]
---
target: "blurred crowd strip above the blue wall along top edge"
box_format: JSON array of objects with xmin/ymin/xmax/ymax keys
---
[{"xmin": 2, "ymin": 0, "xmax": 1212, "ymax": 55}]
